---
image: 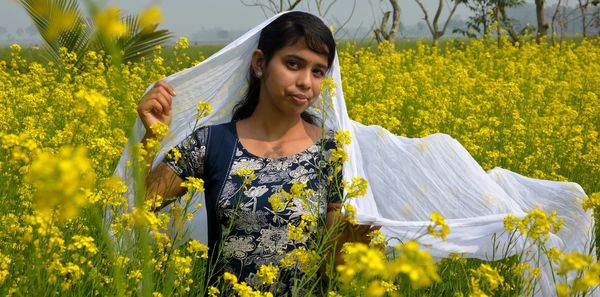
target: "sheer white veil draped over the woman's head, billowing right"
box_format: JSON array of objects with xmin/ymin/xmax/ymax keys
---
[{"xmin": 115, "ymin": 12, "xmax": 593, "ymax": 296}]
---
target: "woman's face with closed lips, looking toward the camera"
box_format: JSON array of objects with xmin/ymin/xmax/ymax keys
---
[{"xmin": 254, "ymin": 39, "xmax": 328, "ymax": 116}]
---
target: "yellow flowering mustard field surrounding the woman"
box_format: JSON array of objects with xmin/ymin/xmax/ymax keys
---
[{"xmin": 0, "ymin": 38, "xmax": 600, "ymax": 296}]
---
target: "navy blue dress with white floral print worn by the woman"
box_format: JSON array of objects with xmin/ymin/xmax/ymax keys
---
[{"xmin": 164, "ymin": 122, "xmax": 339, "ymax": 292}]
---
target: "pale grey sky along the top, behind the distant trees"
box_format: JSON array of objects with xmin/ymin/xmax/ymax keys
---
[{"xmin": 0, "ymin": 0, "xmax": 592, "ymax": 45}]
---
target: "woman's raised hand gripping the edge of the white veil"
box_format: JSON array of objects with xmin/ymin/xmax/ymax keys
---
[{"xmin": 138, "ymin": 80, "xmax": 175, "ymax": 135}]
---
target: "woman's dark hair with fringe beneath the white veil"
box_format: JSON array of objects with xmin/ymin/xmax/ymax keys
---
[{"xmin": 233, "ymin": 11, "xmax": 335, "ymax": 124}]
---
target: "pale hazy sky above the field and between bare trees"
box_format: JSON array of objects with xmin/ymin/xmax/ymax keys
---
[{"xmin": 0, "ymin": 0, "xmax": 556, "ymax": 36}]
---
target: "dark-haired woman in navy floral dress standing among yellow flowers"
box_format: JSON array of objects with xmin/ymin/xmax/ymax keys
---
[{"xmin": 138, "ymin": 12, "xmax": 370, "ymax": 292}]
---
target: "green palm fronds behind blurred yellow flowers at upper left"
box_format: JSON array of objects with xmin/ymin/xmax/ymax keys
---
[{"xmin": 18, "ymin": 0, "xmax": 171, "ymax": 65}]
